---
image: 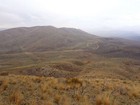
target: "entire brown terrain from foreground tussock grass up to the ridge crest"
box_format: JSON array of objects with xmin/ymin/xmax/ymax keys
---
[{"xmin": 0, "ymin": 26, "xmax": 140, "ymax": 105}]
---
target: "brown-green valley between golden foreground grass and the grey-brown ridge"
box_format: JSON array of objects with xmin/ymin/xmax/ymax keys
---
[{"xmin": 0, "ymin": 47, "xmax": 140, "ymax": 80}]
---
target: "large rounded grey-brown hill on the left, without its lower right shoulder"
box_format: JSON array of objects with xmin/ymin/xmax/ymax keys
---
[{"xmin": 0, "ymin": 26, "xmax": 96, "ymax": 52}]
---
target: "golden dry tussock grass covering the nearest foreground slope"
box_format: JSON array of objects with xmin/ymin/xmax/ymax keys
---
[{"xmin": 0, "ymin": 75, "xmax": 140, "ymax": 105}]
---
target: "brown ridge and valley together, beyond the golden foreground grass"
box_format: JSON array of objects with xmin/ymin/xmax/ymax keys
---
[{"xmin": 0, "ymin": 26, "xmax": 140, "ymax": 78}]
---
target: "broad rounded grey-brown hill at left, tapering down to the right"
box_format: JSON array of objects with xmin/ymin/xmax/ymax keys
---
[{"xmin": 0, "ymin": 26, "xmax": 97, "ymax": 53}]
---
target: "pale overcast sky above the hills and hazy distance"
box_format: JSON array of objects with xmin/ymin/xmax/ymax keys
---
[{"xmin": 0, "ymin": 0, "xmax": 140, "ymax": 31}]
